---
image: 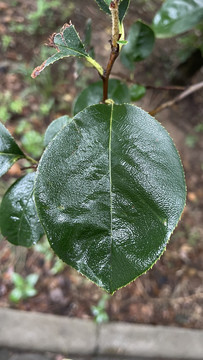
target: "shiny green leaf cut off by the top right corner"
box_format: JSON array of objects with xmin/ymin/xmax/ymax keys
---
[{"xmin": 153, "ymin": 0, "xmax": 203, "ymax": 38}]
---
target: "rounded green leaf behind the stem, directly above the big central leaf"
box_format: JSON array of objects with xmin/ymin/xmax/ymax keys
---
[{"xmin": 73, "ymin": 79, "xmax": 130, "ymax": 115}]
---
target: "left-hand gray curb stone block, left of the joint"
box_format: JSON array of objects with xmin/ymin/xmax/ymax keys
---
[{"xmin": 0, "ymin": 309, "xmax": 96, "ymax": 355}]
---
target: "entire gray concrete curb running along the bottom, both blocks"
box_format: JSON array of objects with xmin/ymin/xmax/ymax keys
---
[{"xmin": 0, "ymin": 308, "xmax": 203, "ymax": 360}]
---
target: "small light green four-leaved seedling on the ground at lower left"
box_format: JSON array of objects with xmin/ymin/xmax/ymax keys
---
[{"xmin": 9, "ymin": 272, "xmax": 39, "ymax": 303}]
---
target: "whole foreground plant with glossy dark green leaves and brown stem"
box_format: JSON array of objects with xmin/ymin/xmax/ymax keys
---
[{"xmin": 0, "ymin": 0, "xmax": 203, "ymax": 292}]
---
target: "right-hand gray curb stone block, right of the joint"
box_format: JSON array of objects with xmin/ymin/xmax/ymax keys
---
[{"xmin": 98, "ymin": 323, "xmax": 203, "ymax": 360}]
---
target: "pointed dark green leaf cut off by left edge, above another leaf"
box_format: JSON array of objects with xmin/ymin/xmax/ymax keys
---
[{"xmin": 0, "ymin": 123, "xmax": 25, "ymax": 176}]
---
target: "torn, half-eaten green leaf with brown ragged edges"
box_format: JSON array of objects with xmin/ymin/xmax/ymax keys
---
[{"xmin": 31, "ymin": 24, "xmax": 103, "ymax": 78}]
